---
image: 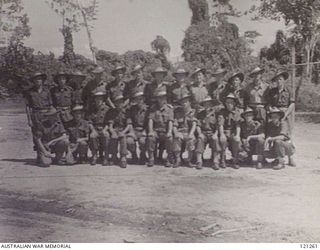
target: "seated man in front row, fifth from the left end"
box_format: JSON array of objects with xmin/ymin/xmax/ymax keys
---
[{"xmin": 127, "ymin": 88, "xmax": 149, "ymax": 164}]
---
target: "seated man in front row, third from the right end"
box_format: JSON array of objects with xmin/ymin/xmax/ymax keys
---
[{"xmin": 218, "ymin": 94, "xmax": 241, "ymax": 169}]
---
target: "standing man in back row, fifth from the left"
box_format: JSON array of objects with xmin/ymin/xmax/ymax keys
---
[{"xmin": 107, "ymin": 65, "xmax": 127, "ymax": 108}]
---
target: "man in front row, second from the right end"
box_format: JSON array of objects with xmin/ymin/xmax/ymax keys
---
[{"xmin": 240, "ymin": 107, "xmax": 265, "ymax": 169}]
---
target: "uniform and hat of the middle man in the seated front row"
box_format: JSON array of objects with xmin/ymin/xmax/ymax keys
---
[{"xmin": 146, "ymin": 90, "xmax": 174, "ymax": 166}]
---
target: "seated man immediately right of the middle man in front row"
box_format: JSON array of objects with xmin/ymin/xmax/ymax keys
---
[{"xmin": 169, "ymin": 89, "xmax": 198, "ymax": 168}]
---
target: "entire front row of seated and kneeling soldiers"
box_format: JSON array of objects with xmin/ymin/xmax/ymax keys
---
[{"xmin": 33, "ymin": 85, "xmax": 296, "ymax": 170}]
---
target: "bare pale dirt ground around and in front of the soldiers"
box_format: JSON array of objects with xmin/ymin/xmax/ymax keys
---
[{"xmin": 0, "ymin": 103, "xmax": 320, "ymax": 242}]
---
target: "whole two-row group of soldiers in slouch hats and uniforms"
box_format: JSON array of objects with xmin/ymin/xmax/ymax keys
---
[{"xmin": 24, "ymin": 65, "xmax": 296, "ymax": 170}]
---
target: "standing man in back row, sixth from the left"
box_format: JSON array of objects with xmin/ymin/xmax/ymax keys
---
[{"xmin": 123, "ymin": 64, "xmax": 149, "ymax": 100}]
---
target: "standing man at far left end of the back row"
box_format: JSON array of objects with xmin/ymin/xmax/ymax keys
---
[{"xmin": 25, "ymin": 72, "xmax": 52, "ymax": 162}]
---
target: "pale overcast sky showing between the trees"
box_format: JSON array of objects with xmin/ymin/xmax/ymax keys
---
[{"xmin": 23, "ymin": 0, "xmax": 284, "ymax": 58}]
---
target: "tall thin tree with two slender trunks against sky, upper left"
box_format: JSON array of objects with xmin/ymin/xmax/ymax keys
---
[{"xmin": 47, "ymin": 0, "xmax": 98, "ymax": 64}]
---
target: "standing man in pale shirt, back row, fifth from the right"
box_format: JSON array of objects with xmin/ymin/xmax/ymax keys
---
[{"xmin": 190, "ymin": 68, "xmax": 209, "ymax": 109}]
